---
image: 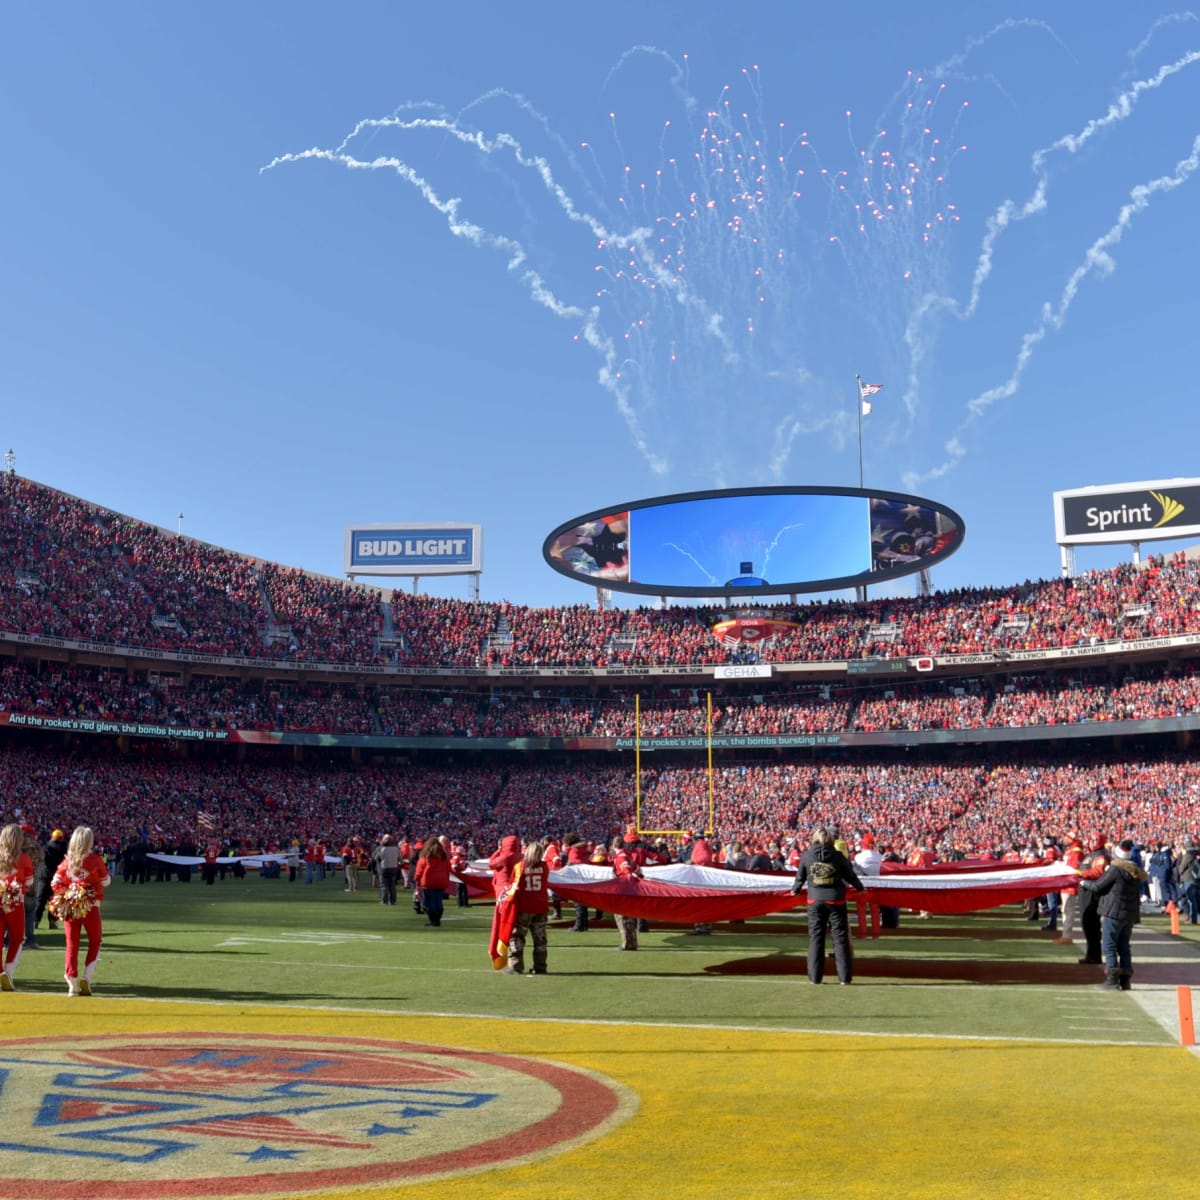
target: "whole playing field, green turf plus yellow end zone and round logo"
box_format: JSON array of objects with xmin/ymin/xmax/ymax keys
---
[{"xmin": 0, "ymin": 875, "xmax": 1200, "ymax": 1200}]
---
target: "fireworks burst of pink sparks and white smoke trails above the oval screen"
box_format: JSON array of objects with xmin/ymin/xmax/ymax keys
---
[{"xmin": 264, "ymin": 20, "xmax": 1200, "ymax": 501}]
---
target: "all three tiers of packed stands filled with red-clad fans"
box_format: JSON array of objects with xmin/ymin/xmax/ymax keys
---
[{"xmin": 0, "ymin": 473, "xmax": 1200, "ymax": 878}]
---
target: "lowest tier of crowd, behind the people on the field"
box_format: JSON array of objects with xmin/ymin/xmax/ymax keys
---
[{"xmin": 9, "ymin": 740, "xmax": 1200, "ymax": 873}]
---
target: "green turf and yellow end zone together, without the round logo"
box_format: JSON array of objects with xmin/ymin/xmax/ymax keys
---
[{"xmin": 0, "ymin": 875, "xmax": 1200, "ymax": 1200}]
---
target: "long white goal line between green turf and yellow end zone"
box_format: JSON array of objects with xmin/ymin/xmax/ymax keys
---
[{"xmin": 79, "ymin": 993, "xmax": 1176, "ymax": 1054}]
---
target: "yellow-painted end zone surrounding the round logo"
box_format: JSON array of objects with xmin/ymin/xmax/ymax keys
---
[{"xmin": 0, "ymin": 994, "xmax": 1198, "ymax": 1200}]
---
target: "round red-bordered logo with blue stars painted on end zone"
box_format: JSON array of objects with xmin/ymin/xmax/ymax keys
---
[{"xmin": 0, "ymin": 1034, "xmax": 631, "ymax": 1200}]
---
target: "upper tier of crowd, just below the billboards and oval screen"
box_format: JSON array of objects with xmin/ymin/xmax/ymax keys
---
[{"xmin": 0, "ymin": 472, "xmax": 1200, "ymax": 668}]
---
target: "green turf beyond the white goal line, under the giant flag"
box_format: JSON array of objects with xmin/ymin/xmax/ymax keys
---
[{"xmin": 19, "ymin": 875, "xmax": 1200, "ymax": 1043}]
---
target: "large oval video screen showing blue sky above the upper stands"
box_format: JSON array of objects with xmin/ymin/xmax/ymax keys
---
[{"xmin": 542, "ymin": 487, "xmax": 965, "ymax": 596}]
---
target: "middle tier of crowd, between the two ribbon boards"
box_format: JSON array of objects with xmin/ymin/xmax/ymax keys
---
[{"xmin": 0, "ymin": 661, "xmax": 1200, "ymax": 738}]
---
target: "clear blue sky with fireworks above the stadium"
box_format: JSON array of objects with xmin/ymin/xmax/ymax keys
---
[{"xmin": 0, "ymin": 0, "xmax": 1200, "ymax": 605}]
